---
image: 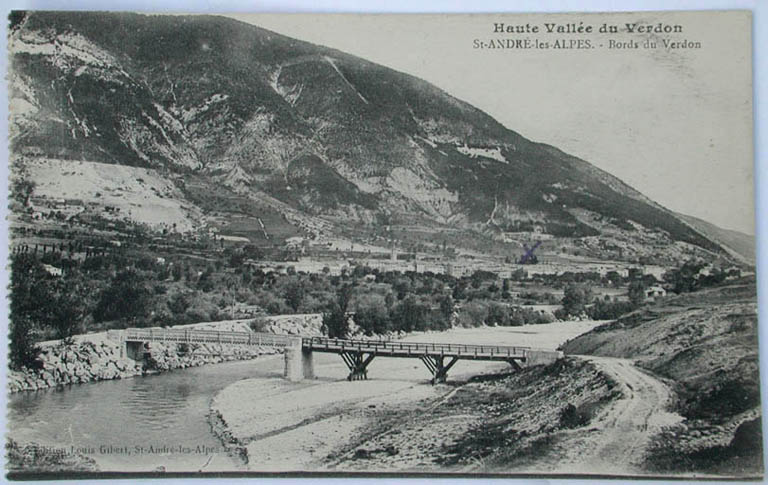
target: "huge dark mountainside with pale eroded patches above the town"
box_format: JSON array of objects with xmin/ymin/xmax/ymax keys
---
[{"xmin": 9, "ymin": 12, "xmax": 723, "ymax": 259}]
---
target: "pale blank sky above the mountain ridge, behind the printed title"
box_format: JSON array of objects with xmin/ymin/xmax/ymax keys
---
[{"xmin": 229, "ymin": 12, "xmax": 755, "ymax": 234}]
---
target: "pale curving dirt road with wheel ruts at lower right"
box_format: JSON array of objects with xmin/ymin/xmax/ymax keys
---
[{"xmin": 546, "ymin": 356, "xmax": 683, "ymax": 475}]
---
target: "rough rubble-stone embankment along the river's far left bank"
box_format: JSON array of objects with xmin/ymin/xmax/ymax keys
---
[{"xmin": 8, "ymin": 314, "xmax": 322, "ymax": 393}]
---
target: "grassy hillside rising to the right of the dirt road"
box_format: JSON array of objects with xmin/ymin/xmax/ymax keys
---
[{"xmin": 562, "ymin": 281, "xmax": 763, "ymax": 476}]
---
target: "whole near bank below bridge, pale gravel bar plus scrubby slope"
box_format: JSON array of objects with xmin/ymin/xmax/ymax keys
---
[{"xmin": 211, "ymin": 358, "xmax": 621, "ymax": 472}]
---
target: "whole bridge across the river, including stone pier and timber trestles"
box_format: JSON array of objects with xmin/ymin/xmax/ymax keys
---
[{"xmin": 107, "ymin": 327, "xmax": 562, "ymax": 383}]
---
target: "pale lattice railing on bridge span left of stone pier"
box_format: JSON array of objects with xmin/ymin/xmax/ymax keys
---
[{"xmin": 125, "ymin": 328, "xmax": 296, "ymax": 347}]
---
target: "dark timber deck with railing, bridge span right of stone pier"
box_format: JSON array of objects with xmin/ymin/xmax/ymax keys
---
[{"xmin": 302, "ymin": 337, "xmax": 529, "ymax": 361}]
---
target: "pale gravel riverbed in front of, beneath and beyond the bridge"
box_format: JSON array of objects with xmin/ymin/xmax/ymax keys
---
[{"xmin": 211, "ymin": 322, "xmax": 600, "ymax": 472}]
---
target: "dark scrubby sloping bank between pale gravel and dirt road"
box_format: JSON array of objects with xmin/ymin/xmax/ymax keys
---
[{"xmin": 330, "ymin": 358, "xmax": 621, "ymax": 473}]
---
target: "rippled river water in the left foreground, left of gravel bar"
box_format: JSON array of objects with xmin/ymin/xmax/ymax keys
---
[{"xmin": 8, "ymin": 357, "xmax": 282, "ymax": 471}]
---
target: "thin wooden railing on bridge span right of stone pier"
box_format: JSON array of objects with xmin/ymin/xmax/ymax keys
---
[{"xmin": 302, "ymin": 337, "xmax": 530, "ymax": 357}]
